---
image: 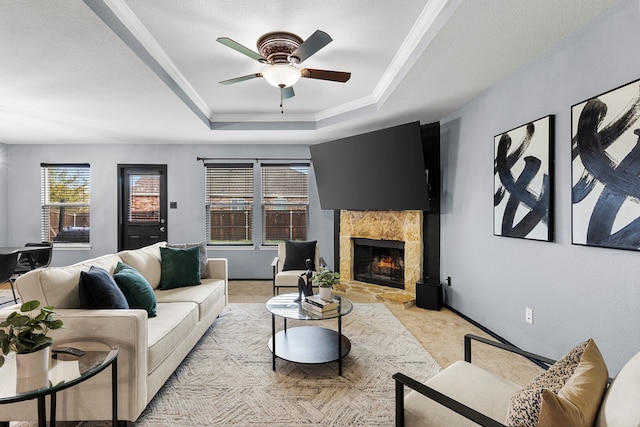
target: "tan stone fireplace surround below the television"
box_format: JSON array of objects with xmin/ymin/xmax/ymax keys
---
[{"xmin": 340, "ymin": 210, "xmax": 423, "ymax": 293}]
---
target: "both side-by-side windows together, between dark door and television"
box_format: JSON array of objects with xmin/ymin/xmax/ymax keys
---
[{"xmin": 204, "ymin": 162, "xmax": 309, "ymax": 246}]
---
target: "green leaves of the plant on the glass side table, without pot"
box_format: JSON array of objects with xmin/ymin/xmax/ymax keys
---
[{"xmin": 0, "ymin": 300, "xmax": 62, "ymax": 367}]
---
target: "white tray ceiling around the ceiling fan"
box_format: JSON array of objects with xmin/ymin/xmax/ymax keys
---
[{"xmin": 0, "ymin": 0, "xmax": 617, "ymax": 144}]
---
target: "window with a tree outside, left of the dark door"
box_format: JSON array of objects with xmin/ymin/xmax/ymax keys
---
[{"xmin": 40, "ymin": 163, "xmax": 90, "ymax": 243}]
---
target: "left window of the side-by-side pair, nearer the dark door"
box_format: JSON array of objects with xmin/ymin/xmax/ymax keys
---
[{"xmin": 205, "ymin": 163, "xmax": 253, "ymax": 245}]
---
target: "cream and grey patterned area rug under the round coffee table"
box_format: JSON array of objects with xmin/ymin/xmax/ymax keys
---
[{"xmin": 12, "ymin": 304, "xmax": 440, "ymax": 427}]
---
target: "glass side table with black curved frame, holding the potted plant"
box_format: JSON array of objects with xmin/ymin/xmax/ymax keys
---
[{"xmin": 0, "ymin": 341, "xmax": 119, "ymax": 427}]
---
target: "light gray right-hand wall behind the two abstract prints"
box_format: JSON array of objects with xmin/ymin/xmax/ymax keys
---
[{"xmin": 441, "ymin": 0, "xmax": 640, "ymax": 375}]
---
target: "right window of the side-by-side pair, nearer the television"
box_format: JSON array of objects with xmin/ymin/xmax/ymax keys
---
[{"xmin": 261, "ymin": 164, "xmax": 309, "ymax": 245}]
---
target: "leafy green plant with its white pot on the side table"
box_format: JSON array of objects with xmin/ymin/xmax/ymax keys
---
[{"xmin": 0, "ymin": 300, "xmax": 62, "ymax": 377}]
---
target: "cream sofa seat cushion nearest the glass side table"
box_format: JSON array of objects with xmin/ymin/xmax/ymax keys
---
[{"xmin": 147, "ymin": 302, "xmax": 198, "ymax": 374}]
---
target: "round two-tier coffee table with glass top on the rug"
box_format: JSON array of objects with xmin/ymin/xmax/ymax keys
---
[{"xmin": 267, "ymin": 293, "xmax": 353, "ymax": 375}]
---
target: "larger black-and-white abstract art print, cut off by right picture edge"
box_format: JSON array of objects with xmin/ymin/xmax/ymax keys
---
[{"xmin": 571, "ymin": 80, "xmax": 640, "ymax": 250}]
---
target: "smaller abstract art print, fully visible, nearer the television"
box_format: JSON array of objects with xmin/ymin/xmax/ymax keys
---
[{"xmin": 493, "ymin": 115, "xmax": 554, "ymax": 242}]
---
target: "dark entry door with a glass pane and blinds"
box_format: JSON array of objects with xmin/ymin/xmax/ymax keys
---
[{"xmin": 118, "ymin": 165, "xmax": 167, "ymax": 250}]
